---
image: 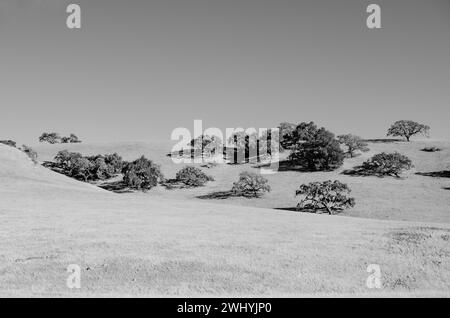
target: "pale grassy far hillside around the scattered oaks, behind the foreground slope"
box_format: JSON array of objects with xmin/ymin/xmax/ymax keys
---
[{"xmin": 32, "ymin": 141, "xmax": 450, "ymax": 223}]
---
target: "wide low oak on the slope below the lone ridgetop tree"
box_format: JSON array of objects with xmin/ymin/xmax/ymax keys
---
[{"xmin": 360, "ymin": 152, "xmax": 413, "ymax": 178}]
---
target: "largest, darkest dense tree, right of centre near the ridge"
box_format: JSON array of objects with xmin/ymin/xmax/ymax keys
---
[{"xmin": 289, "ymin": 123, "xmax": 344, "ymax": 171}]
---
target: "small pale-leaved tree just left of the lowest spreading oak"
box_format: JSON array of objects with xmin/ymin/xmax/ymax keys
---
[{"xmin": 231, "ymin": 172, "xmax": 271, "ymax": 198}]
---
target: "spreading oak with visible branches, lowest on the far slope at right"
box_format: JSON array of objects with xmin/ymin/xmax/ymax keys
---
[{"xmin": 295, "ymin": 180, "xmax": 355, "ymax": 215}]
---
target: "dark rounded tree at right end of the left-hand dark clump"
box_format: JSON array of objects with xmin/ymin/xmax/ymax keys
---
[{"xmin": 122, "ymin": 156, "xmax": 164, "ymax": 190}]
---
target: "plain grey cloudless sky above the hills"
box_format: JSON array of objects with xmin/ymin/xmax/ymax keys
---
[{"xmin": 0, "ymin": 0, "xmax": 450, "ymax": 143}]
